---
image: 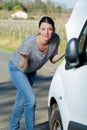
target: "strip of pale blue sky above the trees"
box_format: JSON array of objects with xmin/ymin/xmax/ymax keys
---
[{"xmin": 42, "ymin": 0, "xmax": 78, "ymax": 8}]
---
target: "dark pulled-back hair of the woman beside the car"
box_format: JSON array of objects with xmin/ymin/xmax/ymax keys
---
[{"xmin": 39, "ymin": 16, "xmax": 55, "ymax": 31}]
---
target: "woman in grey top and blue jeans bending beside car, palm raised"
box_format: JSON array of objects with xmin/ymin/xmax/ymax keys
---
[{"xmin": 8, "ymin": 16, "xmax": 65, "ymax": 130}]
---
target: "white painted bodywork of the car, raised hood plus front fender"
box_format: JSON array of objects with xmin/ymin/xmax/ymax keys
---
[{"xmin": 48, "ymin": 0, "xmax": 87, "ymax": 130}]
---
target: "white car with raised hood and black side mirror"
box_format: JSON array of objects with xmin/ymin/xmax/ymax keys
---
[{"xmin": 48, "ymin": 0, "xmax": 87, "ymax": 130}]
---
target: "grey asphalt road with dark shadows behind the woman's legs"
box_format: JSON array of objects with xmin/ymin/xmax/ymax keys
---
[{"xmin": 0, "ymin": 50, "xmax": 58, "ymax": 130}]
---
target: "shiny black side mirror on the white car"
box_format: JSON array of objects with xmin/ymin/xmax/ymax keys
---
[{"xmin": 65, "ymin": 38, "xmax": 79, "ymax": 69}]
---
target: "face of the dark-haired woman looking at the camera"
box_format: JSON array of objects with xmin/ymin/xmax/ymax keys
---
[{"xmin": 39, "ymin": 22, "xmax": 54, "ymax": 41}]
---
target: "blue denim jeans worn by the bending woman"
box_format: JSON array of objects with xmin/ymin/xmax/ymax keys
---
[{"xmin": 8, "ymin": 61, "xmax": 36, "ymax": 130}]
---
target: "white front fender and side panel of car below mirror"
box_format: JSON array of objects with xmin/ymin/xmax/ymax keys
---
[{"xmin": 48, "ymin": 61, "xmax": 87, "ymax": 130}]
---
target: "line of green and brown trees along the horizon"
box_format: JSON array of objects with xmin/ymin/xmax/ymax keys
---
[{"xmin": 0, "ymin": 0, "xmax": 63, "ymax": 13}]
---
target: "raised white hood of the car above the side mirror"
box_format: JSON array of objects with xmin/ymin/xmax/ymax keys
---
[{"xmin": 65, "ymin": 0, "xmax": 87, "ymax": 40}]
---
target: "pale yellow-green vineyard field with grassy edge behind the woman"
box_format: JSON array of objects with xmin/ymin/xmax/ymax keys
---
[{"xmin": 0, "ymin": 14, "xmax": 69, "ymax": 51}]
